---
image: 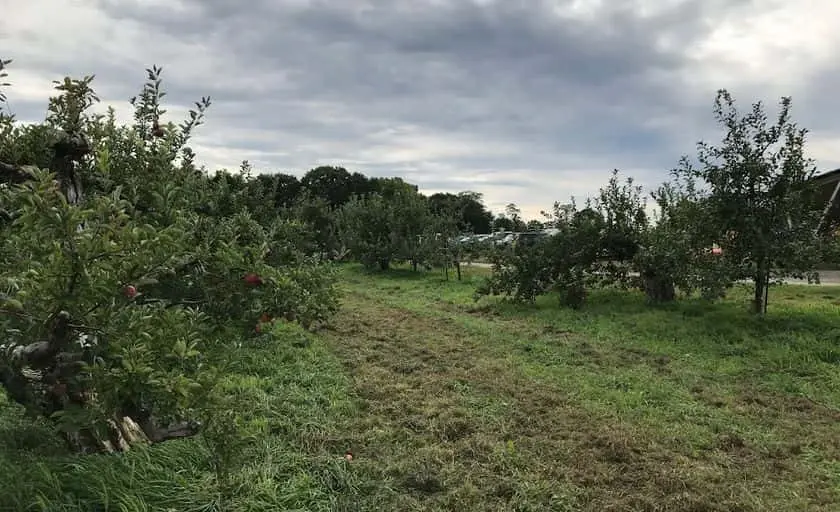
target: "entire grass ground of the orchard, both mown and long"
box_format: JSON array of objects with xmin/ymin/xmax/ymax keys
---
[{"xmin": 0, "ymin": 267, "xmax": 840, "ymax": 512}]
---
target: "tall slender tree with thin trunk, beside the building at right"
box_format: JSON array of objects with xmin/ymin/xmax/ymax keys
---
[{"xmin": 677, "ymin": 90, "xmax": 822, "ymax": 313}]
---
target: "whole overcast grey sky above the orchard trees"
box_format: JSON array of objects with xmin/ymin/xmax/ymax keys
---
[{"xmin": 0, "ymin": 0, "xmax": 840, "ymax": 216}]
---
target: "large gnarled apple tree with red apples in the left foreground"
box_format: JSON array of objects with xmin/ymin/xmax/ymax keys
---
[{"xmin": 0, "ymin": 61, "xmax": 337, "ymax": 452}]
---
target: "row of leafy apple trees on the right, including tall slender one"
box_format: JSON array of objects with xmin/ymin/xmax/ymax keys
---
[{"xmin": 477, "ymin": 90, "xmax": 836, "ymax": 313}]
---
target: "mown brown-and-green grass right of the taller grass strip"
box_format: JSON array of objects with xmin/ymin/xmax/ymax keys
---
[{"xmin": 326, "ymin": 267, "xmax": 840, "ymax": 512}]
